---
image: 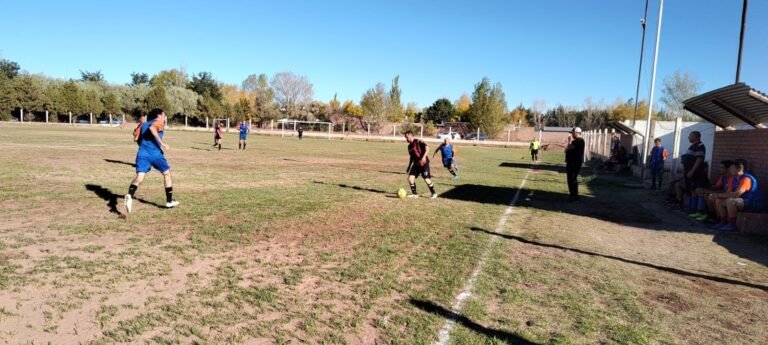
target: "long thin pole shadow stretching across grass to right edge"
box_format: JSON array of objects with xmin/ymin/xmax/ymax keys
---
[{"xmin": 470, "ymin": 227, "xmax": 768, "ymax": 291}]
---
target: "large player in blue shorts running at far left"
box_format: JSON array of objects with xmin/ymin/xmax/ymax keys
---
[{"xmin": 125, "ymin": 109, "xmax": 179, "ymax": 213}]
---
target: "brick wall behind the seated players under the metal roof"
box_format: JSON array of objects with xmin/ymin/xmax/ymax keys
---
[{"xmin": 711, "ymin": 129, "xmax": 768, "ymax": 203}]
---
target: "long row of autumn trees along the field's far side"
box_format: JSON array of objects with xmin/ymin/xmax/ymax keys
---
[{"xmin": 0, "ymin": 59, "xmax": 700, "ymax": 137}]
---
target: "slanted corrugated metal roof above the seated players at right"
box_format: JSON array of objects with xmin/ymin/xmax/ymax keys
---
[{"xmin": 683, "ymin": 83, "xmax": 768, "ymax": 130}]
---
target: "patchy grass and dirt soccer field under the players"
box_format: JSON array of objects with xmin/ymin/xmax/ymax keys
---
[{"xmin": 0, "ymin": 124, "xmax": 768, "ymax": 344}]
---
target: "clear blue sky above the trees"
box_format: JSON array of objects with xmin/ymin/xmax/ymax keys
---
[{"xmin": 0, "ymin": 0, "xmax": 768, "ymax": 107}]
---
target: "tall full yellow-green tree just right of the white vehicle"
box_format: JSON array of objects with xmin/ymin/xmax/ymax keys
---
[{"xmin": 467, "ymin": 78, "xmax": 508, "ymax": 137}]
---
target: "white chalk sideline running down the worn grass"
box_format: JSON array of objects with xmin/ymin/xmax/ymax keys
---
[{"xmin": 435, "ymin": 167, "xmax": 533, "ymax": 345}]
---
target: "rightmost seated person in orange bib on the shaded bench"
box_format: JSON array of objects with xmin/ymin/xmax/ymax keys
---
[{"xmin": 715, "ymin": 159, "xmax": 765, "ymax": 231}]
